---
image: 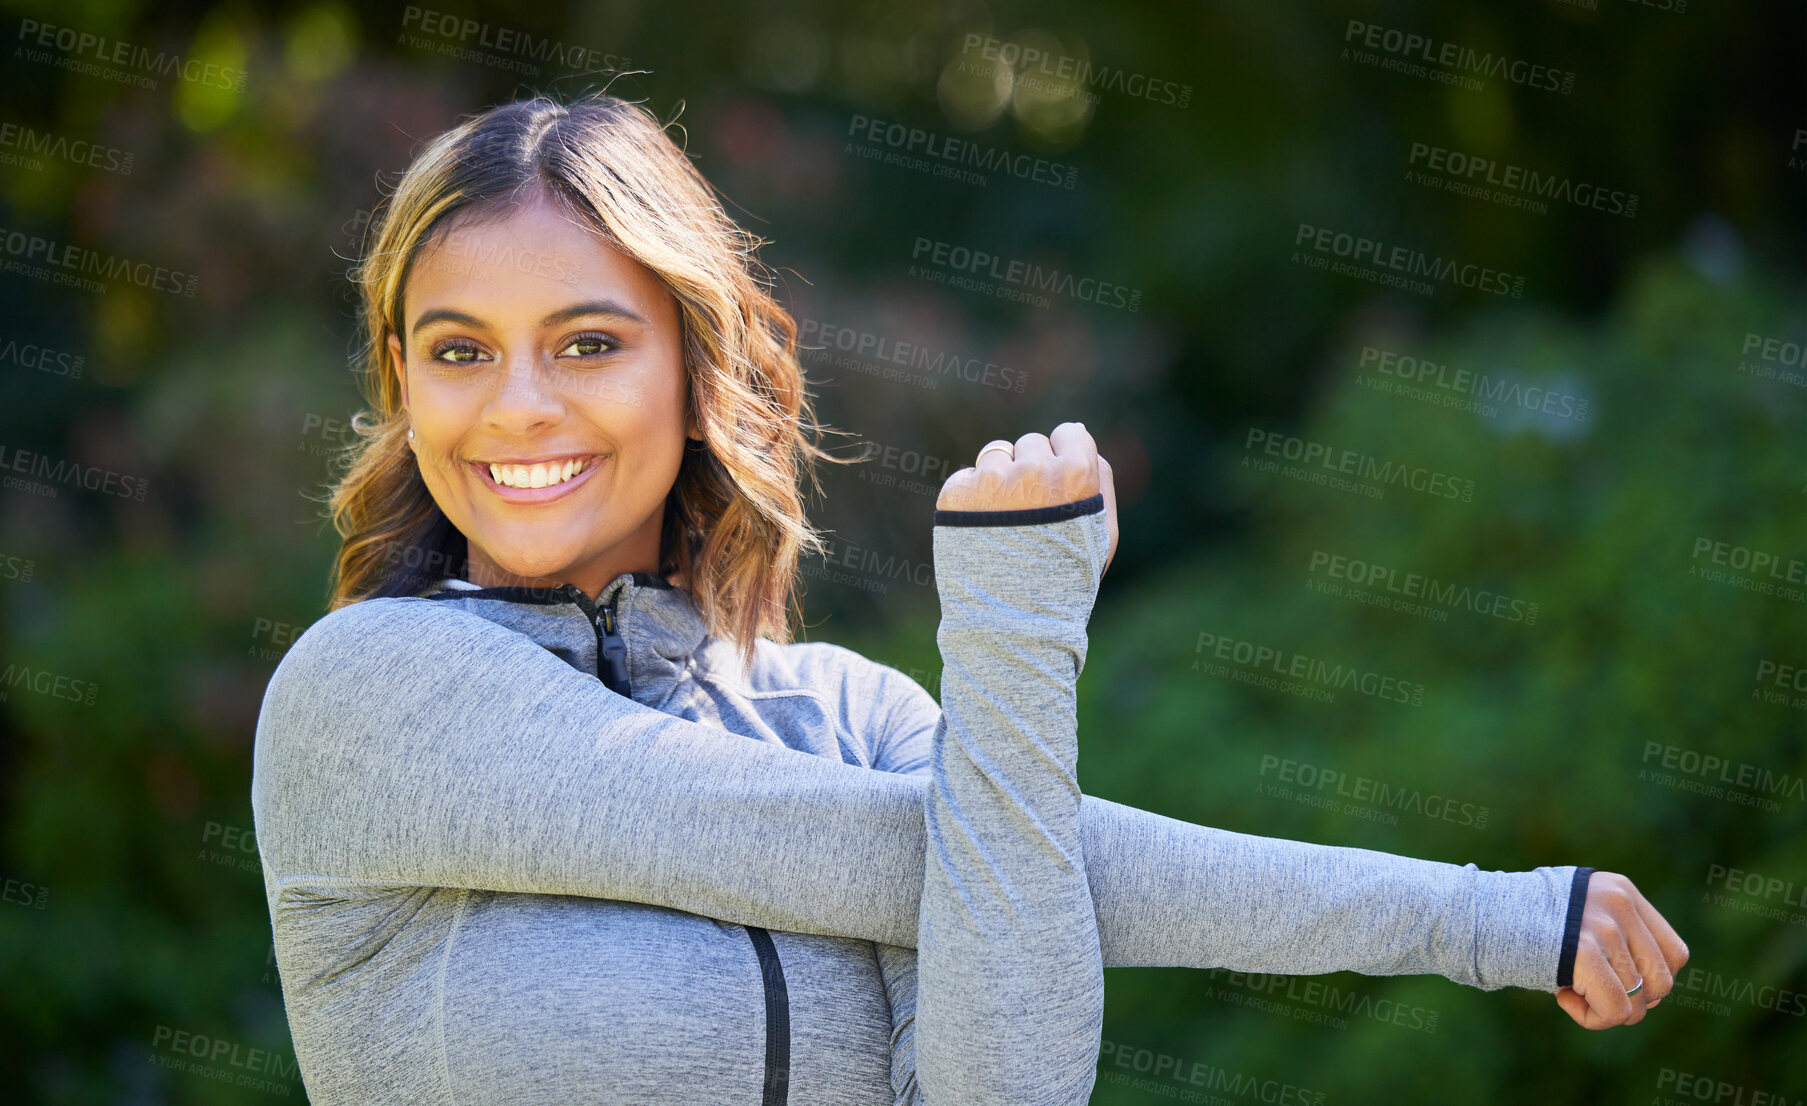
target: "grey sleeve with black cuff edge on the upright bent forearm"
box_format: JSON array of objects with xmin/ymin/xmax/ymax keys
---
[{"xmin": 917, "ymin": 495, "xmax": 1109, "ymax": 1106}]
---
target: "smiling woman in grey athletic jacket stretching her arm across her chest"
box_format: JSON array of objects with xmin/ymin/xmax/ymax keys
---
[{"xmin": 251, "ymin": 96, "xmax": 1686, "ymax": 1106}]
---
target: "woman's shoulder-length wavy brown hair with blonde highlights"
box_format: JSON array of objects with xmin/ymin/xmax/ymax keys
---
[{"xmin": 327, "ymin": 92, "xmax": 847, "ymax": 665}]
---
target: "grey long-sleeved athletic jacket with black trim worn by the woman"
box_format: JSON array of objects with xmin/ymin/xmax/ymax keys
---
[{"xmin": 251, "ymin": 495, "xmax": 1592, "ymax": 1106}]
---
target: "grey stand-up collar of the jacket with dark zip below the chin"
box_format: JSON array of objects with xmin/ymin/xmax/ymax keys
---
[{"xmin": 419, "ymin": 573, "xmax": 708, "ymax": 707}]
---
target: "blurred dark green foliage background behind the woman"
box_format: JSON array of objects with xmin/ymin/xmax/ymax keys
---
[{"xmin": 0, "ymin": 0, "xmax": 1807, "ymax": 1104}]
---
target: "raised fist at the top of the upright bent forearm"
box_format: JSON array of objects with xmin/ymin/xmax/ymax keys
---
[{"xmin": 934, "ymin": 423, "xmax": 1117, "ymax": 571}]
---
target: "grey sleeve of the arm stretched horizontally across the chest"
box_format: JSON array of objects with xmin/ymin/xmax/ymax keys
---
[{"xmin": 251, "ymin": 571, "xmax": 1574, "ymax": 990}]
